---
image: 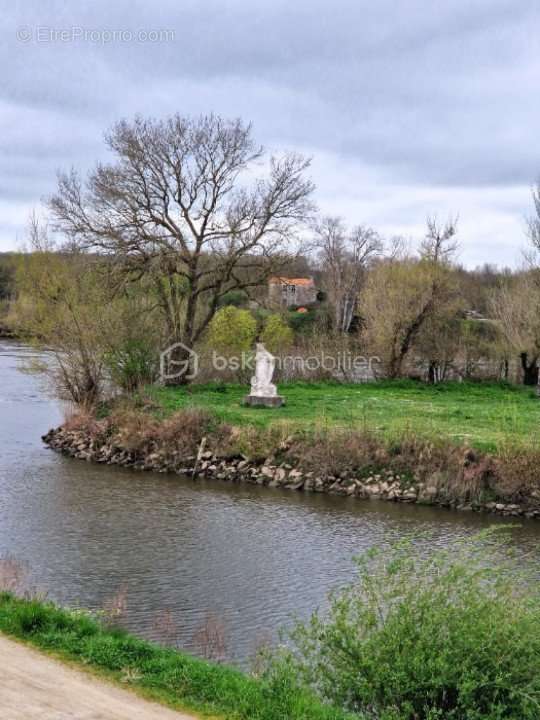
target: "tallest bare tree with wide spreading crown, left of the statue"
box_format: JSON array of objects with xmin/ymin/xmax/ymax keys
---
[{"xmin": 49, "ymin": 115, "xmax": 313, "ymax": 382}]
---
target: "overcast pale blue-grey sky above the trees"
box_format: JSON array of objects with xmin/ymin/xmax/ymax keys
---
[{"xmin": 0, "ymin": 0, "xmax": 540, "ymax": 266}]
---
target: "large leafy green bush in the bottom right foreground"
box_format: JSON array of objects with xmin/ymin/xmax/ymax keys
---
[{"xmin": 269, "ymin": 535, "xmax": 540, "ymax": 720}]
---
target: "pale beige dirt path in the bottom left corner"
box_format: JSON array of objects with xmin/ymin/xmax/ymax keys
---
[{"xmin": 0, "ymin": 635, "xmax": 201, "ymax": 720}]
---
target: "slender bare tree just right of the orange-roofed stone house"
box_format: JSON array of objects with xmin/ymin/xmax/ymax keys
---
[{"xmin": 315, "ymin": 217, "xmax": 382, "ymax": 332}]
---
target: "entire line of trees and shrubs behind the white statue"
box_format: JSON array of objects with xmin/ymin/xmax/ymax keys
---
[{"xmin": 4, "ymin": 115, "xmax": 540, "ymax": 404}]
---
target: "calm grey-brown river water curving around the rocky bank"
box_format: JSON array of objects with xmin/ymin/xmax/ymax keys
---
[{"xmin": 0, "ymin": 341, "xmax": 540, "ymax": 665}]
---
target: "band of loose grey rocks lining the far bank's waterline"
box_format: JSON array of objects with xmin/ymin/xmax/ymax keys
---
[{"xmin": 42, "ymin": 426, "xmax": 540, "ymax": 519}]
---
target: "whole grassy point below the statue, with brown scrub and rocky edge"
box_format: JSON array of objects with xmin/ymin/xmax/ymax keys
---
[{"xmin": 45, "ymin": 381, "xmax": 540, "ymax": 510}]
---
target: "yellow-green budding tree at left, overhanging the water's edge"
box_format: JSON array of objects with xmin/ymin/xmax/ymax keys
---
[{"xmin": 10, "ymin": 213, "xmax": 161, "ymax": 407}]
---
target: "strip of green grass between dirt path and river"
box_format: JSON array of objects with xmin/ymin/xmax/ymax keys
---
[{"xmin": 0, "ymin": 593, "xmax": 358, "ymax": 720}]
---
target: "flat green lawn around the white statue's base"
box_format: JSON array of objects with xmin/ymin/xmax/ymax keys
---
[{"xmin": 149, "ymin": 381, "xmax": 540, "ymax": 450}]
